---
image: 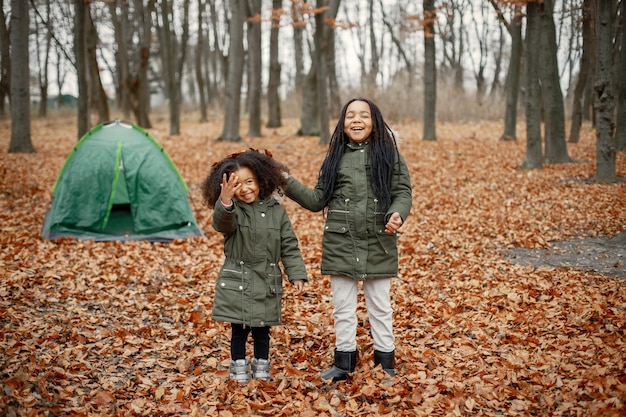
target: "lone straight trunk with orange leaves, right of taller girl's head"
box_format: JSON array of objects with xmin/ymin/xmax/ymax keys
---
[{"xmin": 422, "ymin": 0, "xmax": 437, "ymax": 140}]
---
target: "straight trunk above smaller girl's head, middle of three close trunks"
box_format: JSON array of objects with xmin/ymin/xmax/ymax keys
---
[{"xmin": 248, "ymin": 0, "xmax": 263, "ymax": 138}]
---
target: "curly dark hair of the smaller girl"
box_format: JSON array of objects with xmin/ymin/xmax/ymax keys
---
[{"xmin": 201, "ymin": 148, "xmax": 289, "ymax": 208}]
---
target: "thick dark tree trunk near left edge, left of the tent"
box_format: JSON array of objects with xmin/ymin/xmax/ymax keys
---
[{"xmin": 9, "ymin": 0, "xmax": 35, "ymax": 153}]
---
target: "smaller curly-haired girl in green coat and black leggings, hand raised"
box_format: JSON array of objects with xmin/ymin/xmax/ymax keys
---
[{"xmin": 202, "ymin": 149, "xmax": 307, "ymax": 383}]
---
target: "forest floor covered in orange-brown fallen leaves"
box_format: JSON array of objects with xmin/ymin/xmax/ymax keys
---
[{"xmin": 0, "ymin": 118, "xmax": 626, "ymax": 417}]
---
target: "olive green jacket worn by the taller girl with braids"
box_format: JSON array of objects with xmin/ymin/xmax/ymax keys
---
[{"xmin": 285, "ymin": 143, "xmax": 412, "ymax": 280}]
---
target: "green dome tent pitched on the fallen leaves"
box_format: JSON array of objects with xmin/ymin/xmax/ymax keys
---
[{"xmin": 41, "ymin": 120, "xmax": 202, "ymax": 241}]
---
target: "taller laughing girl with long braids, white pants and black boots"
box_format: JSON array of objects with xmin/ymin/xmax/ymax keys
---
[{"xmin": 285, "ymin": 98, "xmax": 412, "ymax": 381}]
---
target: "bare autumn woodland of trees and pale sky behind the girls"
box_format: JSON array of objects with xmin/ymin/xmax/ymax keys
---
[{"xmin": 0, "ymin": 0, "xmax": 626, "ymax": 181}]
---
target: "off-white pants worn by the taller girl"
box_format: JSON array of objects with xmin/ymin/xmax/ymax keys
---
[{"xmin": 330, "ymin": 276, "xmax": 395, "ymax": 352}]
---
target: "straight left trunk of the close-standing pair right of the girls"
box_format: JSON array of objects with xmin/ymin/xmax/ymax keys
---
[{"xmin": 521, "ymin": 2, "xmax": 543, "ymax": 169}]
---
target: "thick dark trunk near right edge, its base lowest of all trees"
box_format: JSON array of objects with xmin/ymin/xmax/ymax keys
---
[{"xmin": 592, "ymin": 0, "xmax": 616, "ymax": 182}]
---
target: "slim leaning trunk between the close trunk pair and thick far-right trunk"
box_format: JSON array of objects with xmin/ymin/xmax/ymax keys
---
[{"xmin": 569, "ymin": 0, "xmax": 594, "ymax": 143}]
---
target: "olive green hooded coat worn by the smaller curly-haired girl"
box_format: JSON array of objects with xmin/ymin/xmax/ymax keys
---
[{"xmin": 212, "ymin": 198, "xmax": 307, "ymax": 327}]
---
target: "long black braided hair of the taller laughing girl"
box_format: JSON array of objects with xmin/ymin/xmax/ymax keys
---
[{"xmin": 319, "ymin": 98, "xmax": 398, "ymax": 210}]
